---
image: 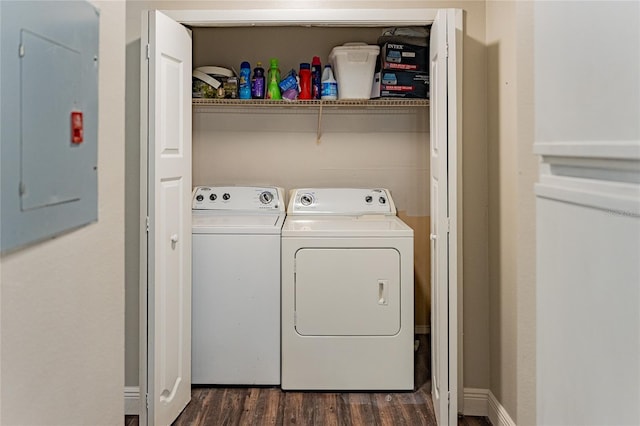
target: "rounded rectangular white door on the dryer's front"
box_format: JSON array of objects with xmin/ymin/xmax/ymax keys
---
[{"xmin": 295, "ymin": 248, "xmax": 400, "ymax": 336}]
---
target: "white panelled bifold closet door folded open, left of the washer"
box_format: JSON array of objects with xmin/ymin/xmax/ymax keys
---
[{"xmin": 140, "ymin": 11, "xmax": 191, "ymax": 425}]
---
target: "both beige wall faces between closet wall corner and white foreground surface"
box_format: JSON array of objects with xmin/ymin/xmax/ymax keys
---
[{"xmin": 487, "ymin": 1, "xmax": 538, "ymax": 425}]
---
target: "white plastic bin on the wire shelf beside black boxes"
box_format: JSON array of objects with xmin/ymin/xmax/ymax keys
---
[{"xmin": 329, "ymin": 43, "xmax": 380, "ymax": 99}]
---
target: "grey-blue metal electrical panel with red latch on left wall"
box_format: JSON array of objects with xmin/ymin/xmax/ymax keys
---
[{"xmin": 0, "ymin": 0, "xmax": 100, "ymax": 252}]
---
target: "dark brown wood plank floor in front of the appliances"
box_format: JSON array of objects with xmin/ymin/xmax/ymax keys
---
[{"xmin": 125, "ymin": 335, "xmax": 491, "ymax": 426}]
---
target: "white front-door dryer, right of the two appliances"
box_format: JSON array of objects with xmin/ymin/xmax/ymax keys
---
[{"xmin": 282, "ymin": 188, "xmax": 414, "ymax": 391}]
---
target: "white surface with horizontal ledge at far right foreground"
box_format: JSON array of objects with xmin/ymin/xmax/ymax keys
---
[{"xmin": 535, "ymin": 1, "xmax": 640, "ymax": 425}]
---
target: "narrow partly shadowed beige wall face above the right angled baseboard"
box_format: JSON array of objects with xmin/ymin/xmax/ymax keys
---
[{"xmin": 487, "ymin": 1, "xmax": 518, "ymax": 415}]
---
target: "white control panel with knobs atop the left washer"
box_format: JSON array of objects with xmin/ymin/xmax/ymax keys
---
[{"xmin": 191, "ymin": 186, "xmax": 285, "ymax": 212}]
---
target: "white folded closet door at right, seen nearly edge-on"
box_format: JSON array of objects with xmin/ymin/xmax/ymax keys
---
[{"xmin": 429, "ymin": 9, "xmax": 462, "ymax": 425}]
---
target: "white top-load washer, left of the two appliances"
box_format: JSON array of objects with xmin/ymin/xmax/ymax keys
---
[{"xmin": 191, "ymin": 186, "xmax": 285, "ymax": 385}]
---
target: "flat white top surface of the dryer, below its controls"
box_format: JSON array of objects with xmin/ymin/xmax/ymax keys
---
[{"xmin": 282, "ymin": 215, "xmax": 413, "ymax": 238}]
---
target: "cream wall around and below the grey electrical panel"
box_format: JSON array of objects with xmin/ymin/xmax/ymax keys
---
[{"xmin": 0, "ymin": 1, "xmax": 125, "ymax": 425}]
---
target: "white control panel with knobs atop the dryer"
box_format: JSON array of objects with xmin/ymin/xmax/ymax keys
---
[{"xmin": 287, "ymin": 188, "xmax": 396, "ymax": 215}]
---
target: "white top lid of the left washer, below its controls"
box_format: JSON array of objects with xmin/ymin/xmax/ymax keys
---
[{"xmin": 192, "ymin": 213, "xmax": 284, "ymax": 234}]
